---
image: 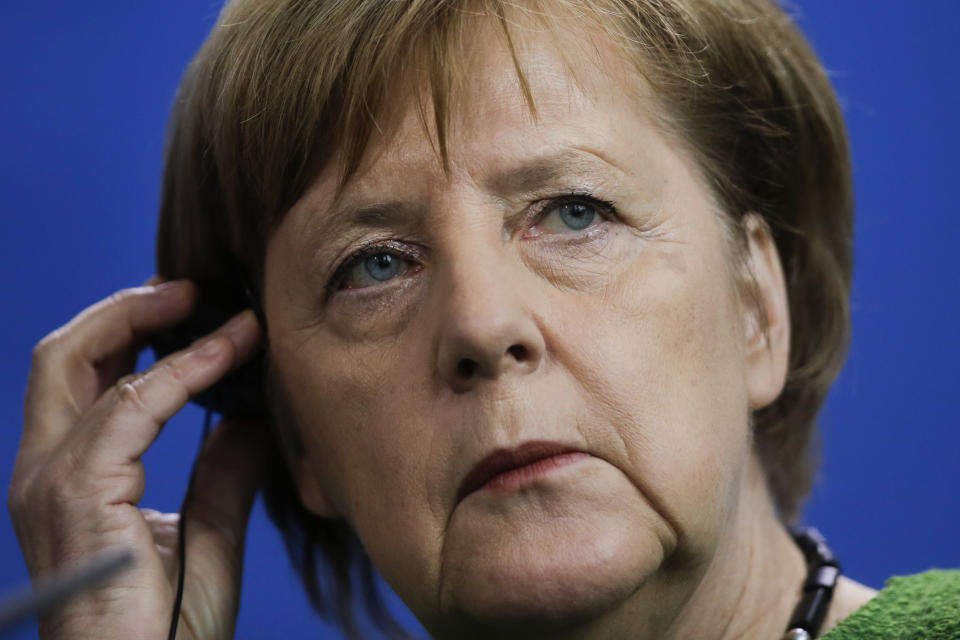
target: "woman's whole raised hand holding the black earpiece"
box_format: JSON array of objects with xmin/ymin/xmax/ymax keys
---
[{"xmin": 8, "ymin": 281, "xmax": 265, "ymax": 639}]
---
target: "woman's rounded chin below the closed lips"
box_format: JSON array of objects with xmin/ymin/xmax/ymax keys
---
[{"xmin": 431, "ymin": 464, "xmax": 665, "ymax": 638}]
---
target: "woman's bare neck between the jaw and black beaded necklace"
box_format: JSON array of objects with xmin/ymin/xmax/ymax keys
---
[{"xmin": 528, "ymin": 460, "xmax": 806, "ymax": 640}]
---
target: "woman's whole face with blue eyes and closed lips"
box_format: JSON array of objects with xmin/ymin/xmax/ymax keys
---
[{"xmin": 266, "ymin": 17, "xmax": 788, "ymax": 633}]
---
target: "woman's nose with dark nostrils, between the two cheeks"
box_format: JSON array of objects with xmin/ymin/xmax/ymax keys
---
[{"xmin": 437, "ymin": 241, "xmax": 545, "ymax": 393}]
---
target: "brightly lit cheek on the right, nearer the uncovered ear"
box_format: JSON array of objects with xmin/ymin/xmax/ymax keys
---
[{"xmin": 555, "ymin": 239, "xmax": 750, "ymax": 539}]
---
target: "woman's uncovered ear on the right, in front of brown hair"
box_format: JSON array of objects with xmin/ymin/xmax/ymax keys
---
[{"xmin": 742, "ymin": 213, "xmax": 790, "ymax": 410}]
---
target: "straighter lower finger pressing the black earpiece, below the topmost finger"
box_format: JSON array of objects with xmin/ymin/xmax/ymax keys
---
[{"xmin": 70, "ymin": 309, "xmax": 260, "ymax": 468}]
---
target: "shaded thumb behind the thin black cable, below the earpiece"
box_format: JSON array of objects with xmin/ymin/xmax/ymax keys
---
[{"xmin": 183, "ymin": 420, "xmax": 269, "ymax": 637}]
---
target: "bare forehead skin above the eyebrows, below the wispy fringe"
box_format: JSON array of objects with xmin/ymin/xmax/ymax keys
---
[{"xmin": 308, "ymin": 3, "xmax": 660, "ymax": 208}]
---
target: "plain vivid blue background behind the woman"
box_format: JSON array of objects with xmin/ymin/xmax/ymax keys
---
[{"xmin": 0, "ymin": 0, "xmax": 960, "ymax": 638}]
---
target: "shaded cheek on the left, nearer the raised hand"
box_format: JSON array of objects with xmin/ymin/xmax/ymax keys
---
[{"xmin": 274, "ymin": 332, "xmax": 449, "ymax": 592}]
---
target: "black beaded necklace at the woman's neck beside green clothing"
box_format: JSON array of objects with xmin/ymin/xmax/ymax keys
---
[{"xmin": 781, "ymin": 527, "xmax": 841, "ymax": 640}]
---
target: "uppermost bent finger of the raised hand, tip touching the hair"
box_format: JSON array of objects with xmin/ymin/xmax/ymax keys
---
[{"xmin": 24, "ymin": 281, "xmax": 196, "ymax": 441}]
